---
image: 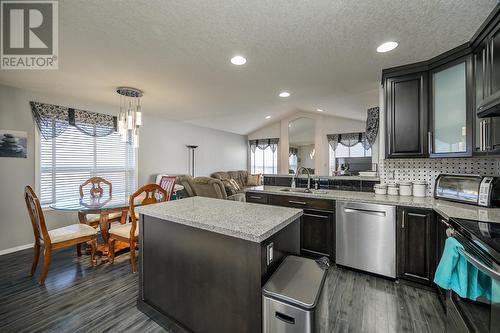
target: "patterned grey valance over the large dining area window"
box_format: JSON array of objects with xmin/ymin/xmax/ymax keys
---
[{"xmin": 30, "ymin": 102, "xmax": 117, "ymax": 139}]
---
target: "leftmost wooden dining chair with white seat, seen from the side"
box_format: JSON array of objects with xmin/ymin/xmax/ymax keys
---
[{"xmin": 24, "ymin": 186, "xmax": 97, "ymax": 285}]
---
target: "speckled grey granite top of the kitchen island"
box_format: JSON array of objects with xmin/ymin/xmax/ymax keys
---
[{"xmin": 136, "ymin": 197, "xmax": 303, "ymax": 243}]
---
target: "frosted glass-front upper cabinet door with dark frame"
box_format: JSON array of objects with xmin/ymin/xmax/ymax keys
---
[{"xmin": 429, "ymin": 57, "xmax": 474, "ymax": 157}]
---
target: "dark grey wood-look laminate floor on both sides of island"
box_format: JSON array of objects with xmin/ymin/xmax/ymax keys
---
[{"xmin": 0, "ymin": 249, "xmax": 445, "ymax": 333}]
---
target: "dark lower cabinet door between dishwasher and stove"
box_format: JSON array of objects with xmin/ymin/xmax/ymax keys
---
[{"xmin": 397, "ymin": 208, "xmax": 436, "ymax": 286}]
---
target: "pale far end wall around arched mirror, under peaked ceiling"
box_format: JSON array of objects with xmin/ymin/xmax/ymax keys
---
[{"xmin": 248, "ymin": 112, "xmax": 366, "ymax": 175}]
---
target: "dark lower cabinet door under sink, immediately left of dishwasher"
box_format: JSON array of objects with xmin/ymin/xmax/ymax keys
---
[{"xmin": 300, "ymin": 210, "xmax": 335, "ymax": 261}]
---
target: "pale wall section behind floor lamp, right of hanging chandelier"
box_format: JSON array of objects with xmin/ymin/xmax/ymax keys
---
[{"xmin": 138, "ymin": 115, "xmax": 248, "ymax": 184}]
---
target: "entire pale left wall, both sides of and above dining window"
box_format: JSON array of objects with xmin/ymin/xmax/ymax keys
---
[{"xmin": 0, "ymin": 85, "xmax": 248, "ymax": 252}]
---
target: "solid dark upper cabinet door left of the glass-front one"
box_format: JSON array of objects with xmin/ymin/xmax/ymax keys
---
[{"xmin": 385, "ymin": 72, "xmax": 428, "ymax": 157}]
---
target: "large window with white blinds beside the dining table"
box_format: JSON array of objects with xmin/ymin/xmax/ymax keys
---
[{"xmin": 39, "ymin": 126, "xmax": 136, "ymax": 206}]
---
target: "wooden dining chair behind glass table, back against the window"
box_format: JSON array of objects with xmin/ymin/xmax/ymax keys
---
[{"xmin": 78, "ymin": 177, "xmax": 124, "ymax": 228}]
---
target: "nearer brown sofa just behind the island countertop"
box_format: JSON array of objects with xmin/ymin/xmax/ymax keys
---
[{"xmin": 176, "ymin": 175, "xmax": 245, "ymax": 201}]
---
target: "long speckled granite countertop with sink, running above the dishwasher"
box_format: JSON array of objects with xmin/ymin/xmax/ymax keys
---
[{"xmin": 246, "ymin": 185, "xmax": 500, "ymax": 223}]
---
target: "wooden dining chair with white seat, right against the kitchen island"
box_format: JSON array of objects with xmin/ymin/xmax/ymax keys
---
[{"xmin": 108, "ymin": 184, "xmax": 168, "ymax": 273}]
